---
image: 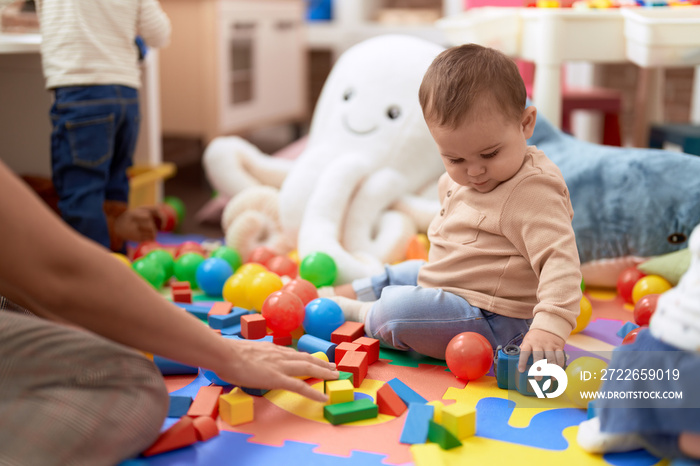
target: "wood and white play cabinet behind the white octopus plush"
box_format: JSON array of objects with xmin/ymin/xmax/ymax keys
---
[{"xmin": 161, "ymin": 0, "xmax": 308, "ymax": 144}]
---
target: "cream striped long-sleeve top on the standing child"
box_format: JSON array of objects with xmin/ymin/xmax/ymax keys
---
[{"xmin": 36, "ymin": 0, "xmax": 170, "ymax": 89}]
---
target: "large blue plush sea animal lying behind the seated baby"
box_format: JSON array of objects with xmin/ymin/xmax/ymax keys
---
[{"xmin": 528, "ymin": 107, "xmax": 700, "ymax": 286}]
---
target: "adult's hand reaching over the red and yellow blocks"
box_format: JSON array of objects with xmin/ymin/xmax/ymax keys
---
[{"xmin": 212, "ymin": 339, "xmax": 338, "ymax": 402}]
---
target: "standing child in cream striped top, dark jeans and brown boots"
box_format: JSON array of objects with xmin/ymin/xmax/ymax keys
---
[{"xmin": 37, "ymin": 0, "xmax": 170, "ymax": 251}]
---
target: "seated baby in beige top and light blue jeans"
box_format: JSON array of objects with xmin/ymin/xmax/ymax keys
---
[{"xmin": 334, "ymin": 44, "xmax": 581, "ymax": 371}]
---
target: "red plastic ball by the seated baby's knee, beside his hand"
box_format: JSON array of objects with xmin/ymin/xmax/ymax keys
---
[{"xmin": 445, "ymin": 332, "xmax": 493, "ymax": 380}]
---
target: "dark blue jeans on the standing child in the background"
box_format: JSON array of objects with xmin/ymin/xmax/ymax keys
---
[{"xmin": 51, "ymin": 86, "xmax": 141, "ymax": 248}]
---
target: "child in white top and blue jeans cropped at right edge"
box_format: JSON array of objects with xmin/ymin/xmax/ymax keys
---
[{"xmin": 577, "ymin": 226, "xmax": 700, "ymax": 460}]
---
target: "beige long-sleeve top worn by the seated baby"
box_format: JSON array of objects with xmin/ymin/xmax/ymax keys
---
[{"xmin": 418, "ymin": 146, "xmax": 581, "ymax": 339}]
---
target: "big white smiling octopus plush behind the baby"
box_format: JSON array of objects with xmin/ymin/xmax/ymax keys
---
[{"xmin": 204, "ymin": 35, "xmax": 444, "ymax": 283}]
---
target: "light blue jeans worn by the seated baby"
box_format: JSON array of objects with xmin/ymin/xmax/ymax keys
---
[{"xmin": 353, "ymin": 260, "xmax": 532, "ymax": 359}]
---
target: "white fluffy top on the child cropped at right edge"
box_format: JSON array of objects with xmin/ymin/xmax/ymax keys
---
[{"xmin": 649, "ymin": 226, "xmax": 700, "ymax": 351}]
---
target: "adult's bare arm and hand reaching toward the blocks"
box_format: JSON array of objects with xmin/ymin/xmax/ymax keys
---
[{"xmin": 0, "ymin": 161, "xmax": 337, "ymax": 401}]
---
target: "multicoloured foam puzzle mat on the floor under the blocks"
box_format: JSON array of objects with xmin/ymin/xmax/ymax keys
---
[{"xmin": 122, "ymin": 237, "xmax": 667, "ymax": 466}]
